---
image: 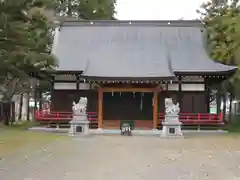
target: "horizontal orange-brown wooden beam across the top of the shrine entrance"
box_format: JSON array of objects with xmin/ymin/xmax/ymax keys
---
[{"xmin": 103, "ymin": 87, "xmax": 156, "ymax": 92}]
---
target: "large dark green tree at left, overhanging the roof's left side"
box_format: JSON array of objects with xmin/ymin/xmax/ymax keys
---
[{"xmin": 0, "ymin": 0, "xmax": 57, "ymax": 124}]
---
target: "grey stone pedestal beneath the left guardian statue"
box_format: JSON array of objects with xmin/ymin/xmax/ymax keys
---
[{"xmin": 68, "ymin": 113, "xmax": 90, "ymax": 136}]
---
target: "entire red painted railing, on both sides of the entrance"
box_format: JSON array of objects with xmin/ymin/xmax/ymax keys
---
[{"xmin": 35, "ymin": 111, "xmax": 223, "ymax": 125}]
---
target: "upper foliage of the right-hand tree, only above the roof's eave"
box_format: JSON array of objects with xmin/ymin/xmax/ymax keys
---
[{"xmin": 198, "ymin": 0, "xmax": 240, "ymax": 64}]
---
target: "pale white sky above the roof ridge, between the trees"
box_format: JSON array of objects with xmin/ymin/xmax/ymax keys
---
[{"xmin": 116, "ymin": 0, "xmax": 207, "ymax": 20}]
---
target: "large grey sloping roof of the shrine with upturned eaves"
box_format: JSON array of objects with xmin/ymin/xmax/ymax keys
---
[{"xmin": 53, "ymin": 21, "xmax": 235, "ymax": 79}]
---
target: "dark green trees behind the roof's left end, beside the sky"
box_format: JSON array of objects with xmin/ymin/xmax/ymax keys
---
[{"xmin": 55, "ymin": 0, "xmax": 116, "ymax": 20}]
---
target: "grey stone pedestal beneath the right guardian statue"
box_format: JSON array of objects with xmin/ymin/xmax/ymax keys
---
[{"xmin": 161, "ymin": 115, "xmax": 183, "ymax": 137}]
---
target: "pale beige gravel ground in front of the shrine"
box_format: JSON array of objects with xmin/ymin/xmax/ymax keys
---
[{"xmin": 0, "ymin": 135, "xmax": 240, "ymax": 180}]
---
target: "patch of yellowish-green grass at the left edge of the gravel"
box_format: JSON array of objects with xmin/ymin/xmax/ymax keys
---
[{"xmin": 0, "ymin": 123, "xmax": 66, "ymax": 157}]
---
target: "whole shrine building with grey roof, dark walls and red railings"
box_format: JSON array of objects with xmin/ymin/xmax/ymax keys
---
[{"xmin": 35, "ymin": 20, "xmax": 237, "ymax": 129}]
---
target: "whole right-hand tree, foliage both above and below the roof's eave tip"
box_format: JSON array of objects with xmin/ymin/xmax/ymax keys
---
[{"xmin": 198, "ymin": 0, "xmax": 240, "ymax": 121}]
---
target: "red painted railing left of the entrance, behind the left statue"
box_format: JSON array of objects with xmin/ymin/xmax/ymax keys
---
[{"xmin": 35, "ymin": 110, "xmax": 97, "ymax": 121}]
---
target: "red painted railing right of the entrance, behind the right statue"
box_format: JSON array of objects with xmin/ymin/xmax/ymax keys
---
[{"xmin": 158, "ymin": 113, "xmax": 223, "ymax": 125}]
